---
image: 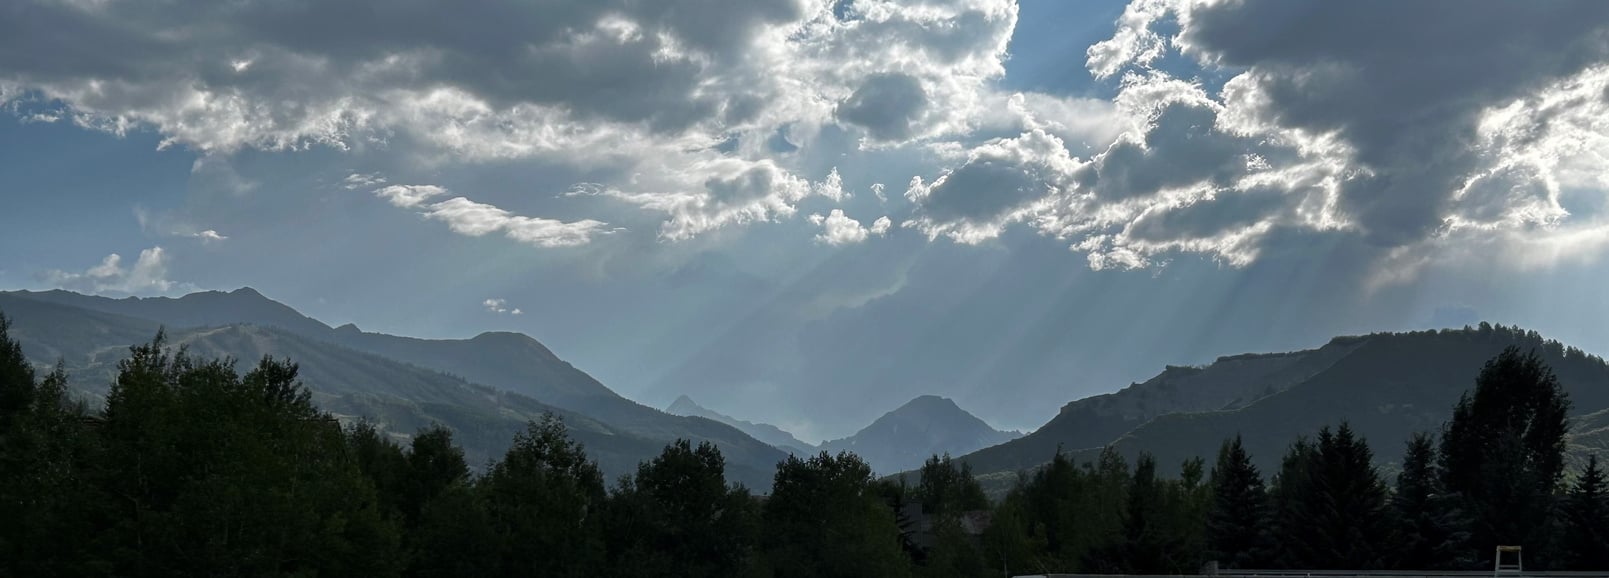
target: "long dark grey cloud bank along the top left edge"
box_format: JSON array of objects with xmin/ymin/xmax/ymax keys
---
[{"xmin": 0, "ymin": 0, "xmax": 803, "ymax": 130}]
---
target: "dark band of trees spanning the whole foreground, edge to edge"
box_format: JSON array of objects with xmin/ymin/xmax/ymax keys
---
[{"xmin": 0, "ymin": 317, "xmax": 1609, "ymax": 576}]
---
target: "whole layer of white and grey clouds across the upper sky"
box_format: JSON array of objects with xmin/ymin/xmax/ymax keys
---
[{"xmin": 9, "ymin": 0, "xmax": 1609, "ymax": 273}]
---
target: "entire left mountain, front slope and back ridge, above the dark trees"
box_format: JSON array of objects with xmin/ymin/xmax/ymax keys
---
[{"xmin": 0, "ymin": 288, "xmax": 787, "ymax": 488}]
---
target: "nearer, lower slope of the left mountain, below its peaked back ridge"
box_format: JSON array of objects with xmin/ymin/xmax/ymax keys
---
[{"xmin": 0, "ymin": 293, "xmax": 785, "ymax": 491}]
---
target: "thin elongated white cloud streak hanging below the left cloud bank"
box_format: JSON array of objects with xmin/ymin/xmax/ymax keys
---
[{"xmin": 373, "ymin": 185, "xmax": 613, "ymax": 248}]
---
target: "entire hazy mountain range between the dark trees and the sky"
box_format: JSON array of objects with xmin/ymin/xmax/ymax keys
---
[{"xmin": 12, "ymin": 288, "xmax": 1609, "ymax": 491}]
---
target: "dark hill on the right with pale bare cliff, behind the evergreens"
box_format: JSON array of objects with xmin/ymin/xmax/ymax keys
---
[{"xmin": 959, "ymin": 324, "xmax": 1609, "ymax": 475}]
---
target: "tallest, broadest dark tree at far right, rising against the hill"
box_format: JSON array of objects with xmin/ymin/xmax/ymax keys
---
[{"xmin": 1440, "ymin": 346, "xmax": 1570, "ymax": 568}]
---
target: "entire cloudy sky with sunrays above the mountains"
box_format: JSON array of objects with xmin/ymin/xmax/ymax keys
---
[{"xmin": 0, "ymin": 0, "xmax": 1609, "ymax": 441}]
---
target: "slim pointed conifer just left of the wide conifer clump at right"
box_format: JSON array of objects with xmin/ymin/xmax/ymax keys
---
[{"xmin": 1207, "ymin": 436, "xmax": 1268, "ymax": 568}]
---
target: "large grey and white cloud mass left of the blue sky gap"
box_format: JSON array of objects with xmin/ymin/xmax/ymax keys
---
[{"xmin": 0, "ymin": 0, "xmax": 1017, "ymax": 240}]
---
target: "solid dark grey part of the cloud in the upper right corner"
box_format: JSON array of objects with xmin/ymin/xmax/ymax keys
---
[{"xmin": 1181, "ymin": 0, "xmax": 1609, "ymax": 245}]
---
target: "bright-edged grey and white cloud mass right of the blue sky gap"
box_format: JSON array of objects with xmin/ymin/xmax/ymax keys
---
[{"xmin": 904, "ymin": 0, "xmax": 1609, "ymax": 279}]
